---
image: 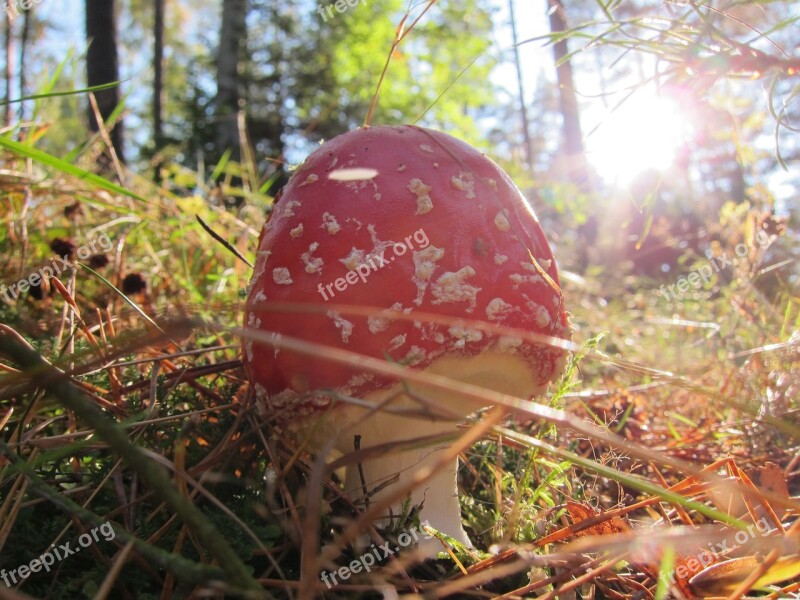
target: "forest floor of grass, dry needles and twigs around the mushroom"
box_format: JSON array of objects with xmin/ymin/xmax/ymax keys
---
[{"xmin": 0, "ymin": 146, "xmax": 800, "ymax": 599}]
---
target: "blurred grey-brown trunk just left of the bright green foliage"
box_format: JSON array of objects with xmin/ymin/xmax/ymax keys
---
[{"xmin": 215, "ymin": 0, "xmax": 247, "ymax": 160}]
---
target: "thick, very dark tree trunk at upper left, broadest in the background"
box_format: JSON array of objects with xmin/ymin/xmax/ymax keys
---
[{"xmin": 86, "ymin": 0, "xmax": 124, "ymax": 167}]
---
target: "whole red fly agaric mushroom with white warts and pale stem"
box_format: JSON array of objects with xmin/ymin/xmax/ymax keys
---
[{"xmin": 243, "ymin": 125, "xmax": 570, "ymax": 555}]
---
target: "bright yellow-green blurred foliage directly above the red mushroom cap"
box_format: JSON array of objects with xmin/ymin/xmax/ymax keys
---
[{"xmin": 315, "ymin": 0, "xmax": 494, "ymax": 141}]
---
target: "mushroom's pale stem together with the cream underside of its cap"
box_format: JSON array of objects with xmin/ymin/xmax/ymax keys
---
[{"xmin": 336, "ymin": 351, "xmax": 552, "ymax": 558}]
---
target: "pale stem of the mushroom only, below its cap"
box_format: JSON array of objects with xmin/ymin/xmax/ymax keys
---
[{"xmin": 339, "ymin": 411, "xmax": 472, "ymax": 558}]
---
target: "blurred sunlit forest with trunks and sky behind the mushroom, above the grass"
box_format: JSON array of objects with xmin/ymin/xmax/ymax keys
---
[{"xmin": 5, "ymin": 0, "xmax": 800, "ymax": 279}]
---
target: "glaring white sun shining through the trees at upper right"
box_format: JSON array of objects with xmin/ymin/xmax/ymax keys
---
[{"xmin": 586, "ymin": 91, "xmax": 692, "ymax": 184}]
